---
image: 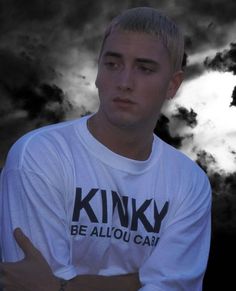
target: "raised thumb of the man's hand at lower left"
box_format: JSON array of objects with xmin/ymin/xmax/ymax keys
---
[{"xmin": 13, "ymin": 228, "xmax": 39, "ymax": 257}]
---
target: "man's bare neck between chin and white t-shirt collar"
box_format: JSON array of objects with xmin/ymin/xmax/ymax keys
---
[{"xmin": 88, "ymin": 114, "xmax": 153, "ymax": 161}]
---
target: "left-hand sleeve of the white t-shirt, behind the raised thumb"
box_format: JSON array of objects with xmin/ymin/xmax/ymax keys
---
[{"xmin": 0, "ymin": 168, "xmax": 77, "ymax": 279}]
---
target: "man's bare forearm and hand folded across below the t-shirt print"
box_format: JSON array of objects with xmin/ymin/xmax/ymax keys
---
[{"xmin": 0, "ymin": 229, "xmax": 141, "ymax": 291}]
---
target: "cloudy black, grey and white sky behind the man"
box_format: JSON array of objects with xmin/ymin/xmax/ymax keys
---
[{"xmin": 0, "ymin": 0, "xmax": 236, "ymax": 231}]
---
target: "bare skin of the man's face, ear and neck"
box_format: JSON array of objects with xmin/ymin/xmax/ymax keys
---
[{"xmin": 89, "ymin": 30, "xmax": 183, "ymax": 160}]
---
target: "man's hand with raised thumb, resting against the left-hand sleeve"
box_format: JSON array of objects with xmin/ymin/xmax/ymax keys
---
[{"xmin": 0, "ymin": 228, "xmax": 60, "ymax": 291}]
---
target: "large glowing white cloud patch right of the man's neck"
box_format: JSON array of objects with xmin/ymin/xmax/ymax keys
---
[{"xmin": 166, "ymin": 72, "xmax": 236, "ymax": 171}]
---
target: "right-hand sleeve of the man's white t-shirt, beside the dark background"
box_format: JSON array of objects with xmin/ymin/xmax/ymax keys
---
[{"xmin": 139, "ymin": 175, "xmax": 211, "ymax": 291}]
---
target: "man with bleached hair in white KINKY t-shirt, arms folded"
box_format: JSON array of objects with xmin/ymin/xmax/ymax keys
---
[{"xmin": 0, "ymin": 8, "xmax": 211, "ymax": 291}]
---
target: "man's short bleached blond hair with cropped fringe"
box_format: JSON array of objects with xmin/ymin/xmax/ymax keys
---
[{"xmin": 100, "ymin": 7, "xmax": 184, "ymax": 72}]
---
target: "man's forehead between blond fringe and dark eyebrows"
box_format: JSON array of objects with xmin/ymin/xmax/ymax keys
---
[{"xmin": 102, "ymin": 30, "xmax": 169, "ymax": 61}]
